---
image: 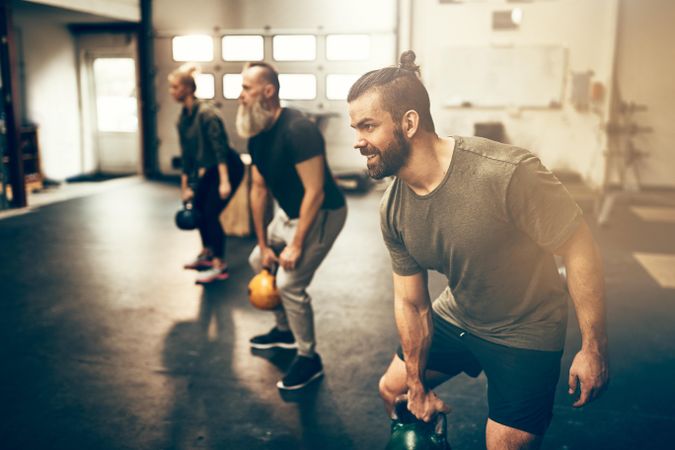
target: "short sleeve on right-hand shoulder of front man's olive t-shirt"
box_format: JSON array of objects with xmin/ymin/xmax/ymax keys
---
[{"xmin": 506, "ymin": 156, "xmax": 583, "ymax": 252}]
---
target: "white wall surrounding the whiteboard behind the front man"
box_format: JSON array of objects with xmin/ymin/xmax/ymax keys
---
[{"xmin": 412, "ymin": 0, "xmax": 618, "ymax": 186}]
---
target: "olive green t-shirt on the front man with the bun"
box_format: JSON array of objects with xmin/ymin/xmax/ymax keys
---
[{"xmin": 380, "ymin": 137, "xmax": 583, "ymax": 351}]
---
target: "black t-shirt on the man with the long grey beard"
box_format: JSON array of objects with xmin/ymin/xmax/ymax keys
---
[{"xmin": 248, "ymin": 108, "xmax": 345, "ymax": 219}]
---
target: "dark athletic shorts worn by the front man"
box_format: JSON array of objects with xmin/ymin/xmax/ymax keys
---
[{"xmin": 397, "ymin": 312, "xmax": 562, "ymax": 435}]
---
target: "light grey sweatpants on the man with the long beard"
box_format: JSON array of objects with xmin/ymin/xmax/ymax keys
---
[{"xmin": 248, "ymin": 206, "xmax": 347, "ymax": 356}]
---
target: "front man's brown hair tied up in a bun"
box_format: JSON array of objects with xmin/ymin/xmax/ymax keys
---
[{"xmin": 347, "ymin": 50, "xmax": 435, "ymax": 133}]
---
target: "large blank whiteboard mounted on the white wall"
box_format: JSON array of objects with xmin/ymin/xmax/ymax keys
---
[{"xmin": 436, "ymin": 46, "xmax": 567, "ymax": 108}]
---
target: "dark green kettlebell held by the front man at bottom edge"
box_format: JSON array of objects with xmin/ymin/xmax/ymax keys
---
[{"xmin": 386, "ymin": 399, "xmax": 450, "ymax": 450}]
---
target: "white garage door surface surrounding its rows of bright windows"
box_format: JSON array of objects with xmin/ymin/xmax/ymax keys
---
[{"xmin": 153, "ymin": 0, "xmax": 396, "ymax": 173}]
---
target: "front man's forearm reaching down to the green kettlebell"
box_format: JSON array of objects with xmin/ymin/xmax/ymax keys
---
[{"xmin": 394, "ymin": 299, "xmax": 433, "ymax": 391}]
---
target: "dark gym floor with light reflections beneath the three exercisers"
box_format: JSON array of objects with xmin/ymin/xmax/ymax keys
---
[{"xmin": 0, "ymin": 182, "xmax": 675, "ymax": 450}]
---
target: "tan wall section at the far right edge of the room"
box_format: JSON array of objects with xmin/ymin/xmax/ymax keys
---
[{"xmin": 616, "ymin": 0, "xmax": 675, "ymax": 188}]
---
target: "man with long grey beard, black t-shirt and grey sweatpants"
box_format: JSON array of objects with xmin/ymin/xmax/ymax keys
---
[{"xmin": 237, "ymin": 62, "xmax": 347, "ymax": 389}]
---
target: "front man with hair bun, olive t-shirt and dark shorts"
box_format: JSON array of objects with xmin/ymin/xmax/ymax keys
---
[{"xmin": 348, "ymin": 51, "xmax": 608, "ymax": 449}]
